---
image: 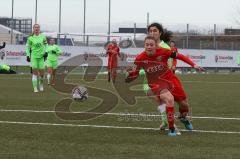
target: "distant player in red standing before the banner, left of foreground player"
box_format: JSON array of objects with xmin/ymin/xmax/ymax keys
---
[{"xmin": 107, "ymin": 40, "xmax": 120, "ymax": 82}]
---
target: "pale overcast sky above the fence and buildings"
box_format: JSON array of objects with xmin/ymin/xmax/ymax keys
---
[{"xmin": 0, "ymin": 0, "xmax": 240, "ymax": 33}]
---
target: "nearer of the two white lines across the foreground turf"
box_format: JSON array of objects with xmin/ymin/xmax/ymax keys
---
[{"xmin": 0, "ymin": 121, "xmax": 240, "ymax": 134}]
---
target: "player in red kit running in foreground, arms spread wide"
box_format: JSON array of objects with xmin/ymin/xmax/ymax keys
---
[{"xmin": 126, "ymin": 36, "xmax": 203, "ymax": 136}]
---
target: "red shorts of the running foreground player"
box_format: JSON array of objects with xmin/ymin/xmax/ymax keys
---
[{"xmin": 169, "ymin": 76, "xmax": 187, "ymax": 101}]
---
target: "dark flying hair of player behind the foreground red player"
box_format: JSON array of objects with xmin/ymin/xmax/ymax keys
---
[{"xmin": 148, "ymin": 22, "xmax": 172, "ymax": 43}]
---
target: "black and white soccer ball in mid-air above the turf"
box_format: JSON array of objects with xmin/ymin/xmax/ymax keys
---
[{"xmin": 72, "ymin": 86, "xmax": 88, "ymax": 102}]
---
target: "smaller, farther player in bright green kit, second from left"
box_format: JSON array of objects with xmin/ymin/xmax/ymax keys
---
[{"xmin": 46, "ymin": 38, "xmax": 62, "ymax": 85}]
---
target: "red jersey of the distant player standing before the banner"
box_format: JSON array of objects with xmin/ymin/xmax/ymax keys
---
[{"xmin": 107, "ymin": 44, "xmax": 120, "ymax": 69}]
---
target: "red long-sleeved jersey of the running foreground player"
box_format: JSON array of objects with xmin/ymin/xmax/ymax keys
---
[{"xmin": 129, "ymin": 48, "xmax": 194, "ymax": 93}]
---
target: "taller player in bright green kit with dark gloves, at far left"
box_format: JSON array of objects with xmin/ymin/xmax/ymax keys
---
[{"xmin": 26, "ymin": 24, "xmax": 47, "ymax": 93}]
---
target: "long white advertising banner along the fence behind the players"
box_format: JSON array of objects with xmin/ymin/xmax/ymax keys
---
[{"xmin": 0, "ymin": 45, "xmax": 240, "ymax": 68}]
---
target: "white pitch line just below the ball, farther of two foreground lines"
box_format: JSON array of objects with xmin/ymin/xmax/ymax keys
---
[{"xmin": 0, "ymin": 109, "xmax": 240, "ymax": 120}]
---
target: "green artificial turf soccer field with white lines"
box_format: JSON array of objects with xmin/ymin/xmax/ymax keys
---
[{"xmin": 0, "ymin": 74, "xmax": 240, "ymax": 159}]
